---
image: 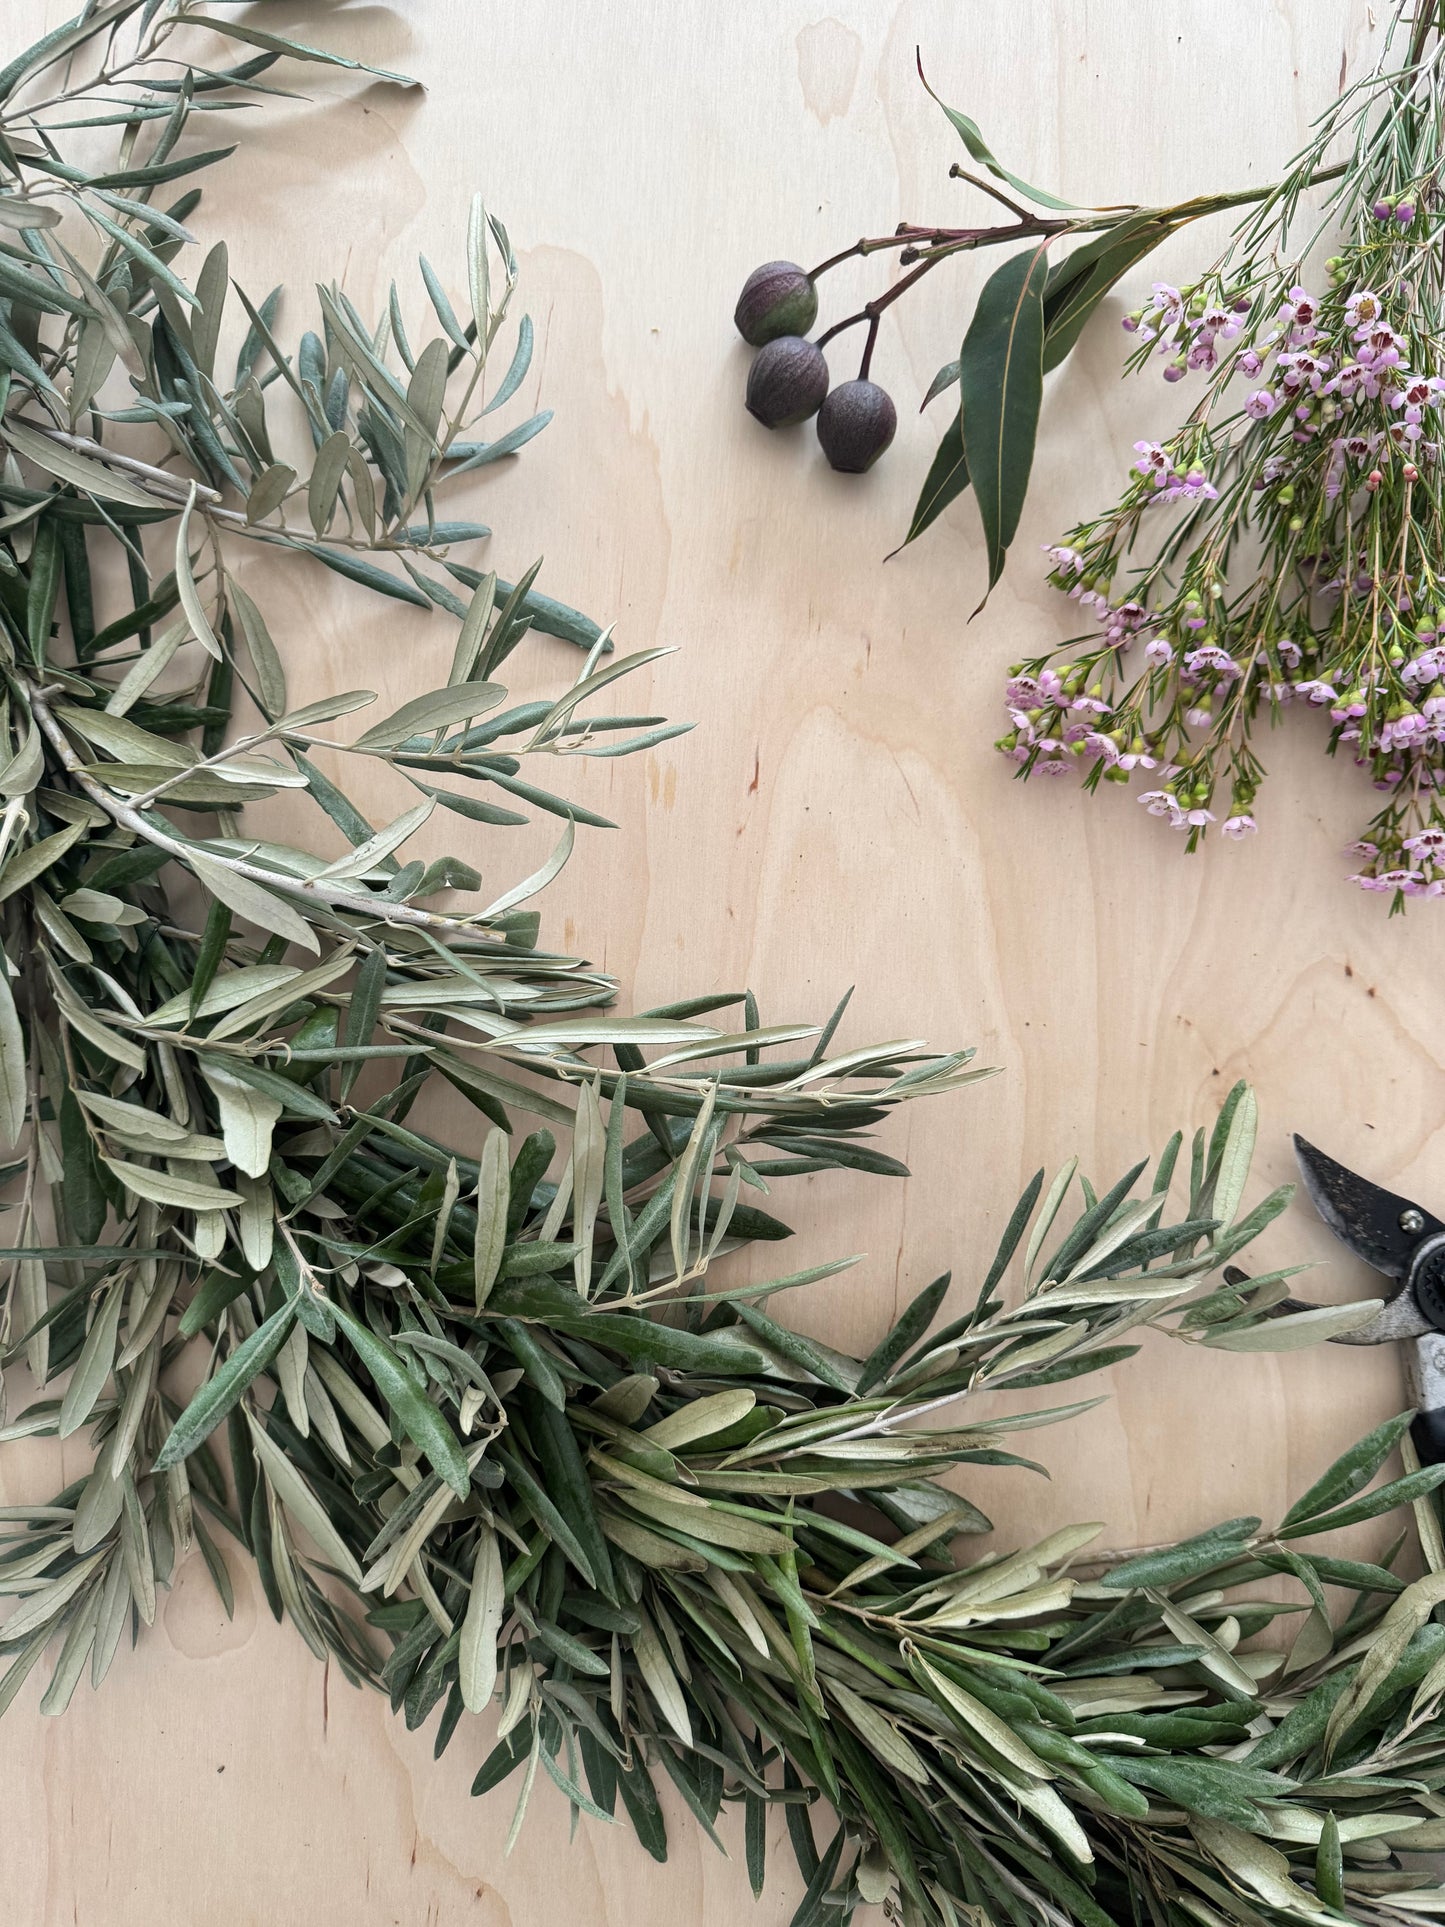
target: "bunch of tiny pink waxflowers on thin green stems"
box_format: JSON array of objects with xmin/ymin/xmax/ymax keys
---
[{"xmin": 998, "ymin": 121, "xmax": 1445, "ymax": 908}]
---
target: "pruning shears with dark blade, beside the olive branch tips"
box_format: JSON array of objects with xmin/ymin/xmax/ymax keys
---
[{"xmin": 1281, "ymin": 1137, "xmax": 1445, "ymax": 1465}]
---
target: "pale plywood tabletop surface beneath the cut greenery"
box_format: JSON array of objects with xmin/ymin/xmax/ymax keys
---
[{"xmin": 0, "ymin": 0, "xmax": 1445, "ymax": 1927}]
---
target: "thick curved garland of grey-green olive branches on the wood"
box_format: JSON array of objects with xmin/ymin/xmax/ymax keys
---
[{"xmin": 0, "ymin": 0, "xmax": 1445, "ymax": 1927}]
